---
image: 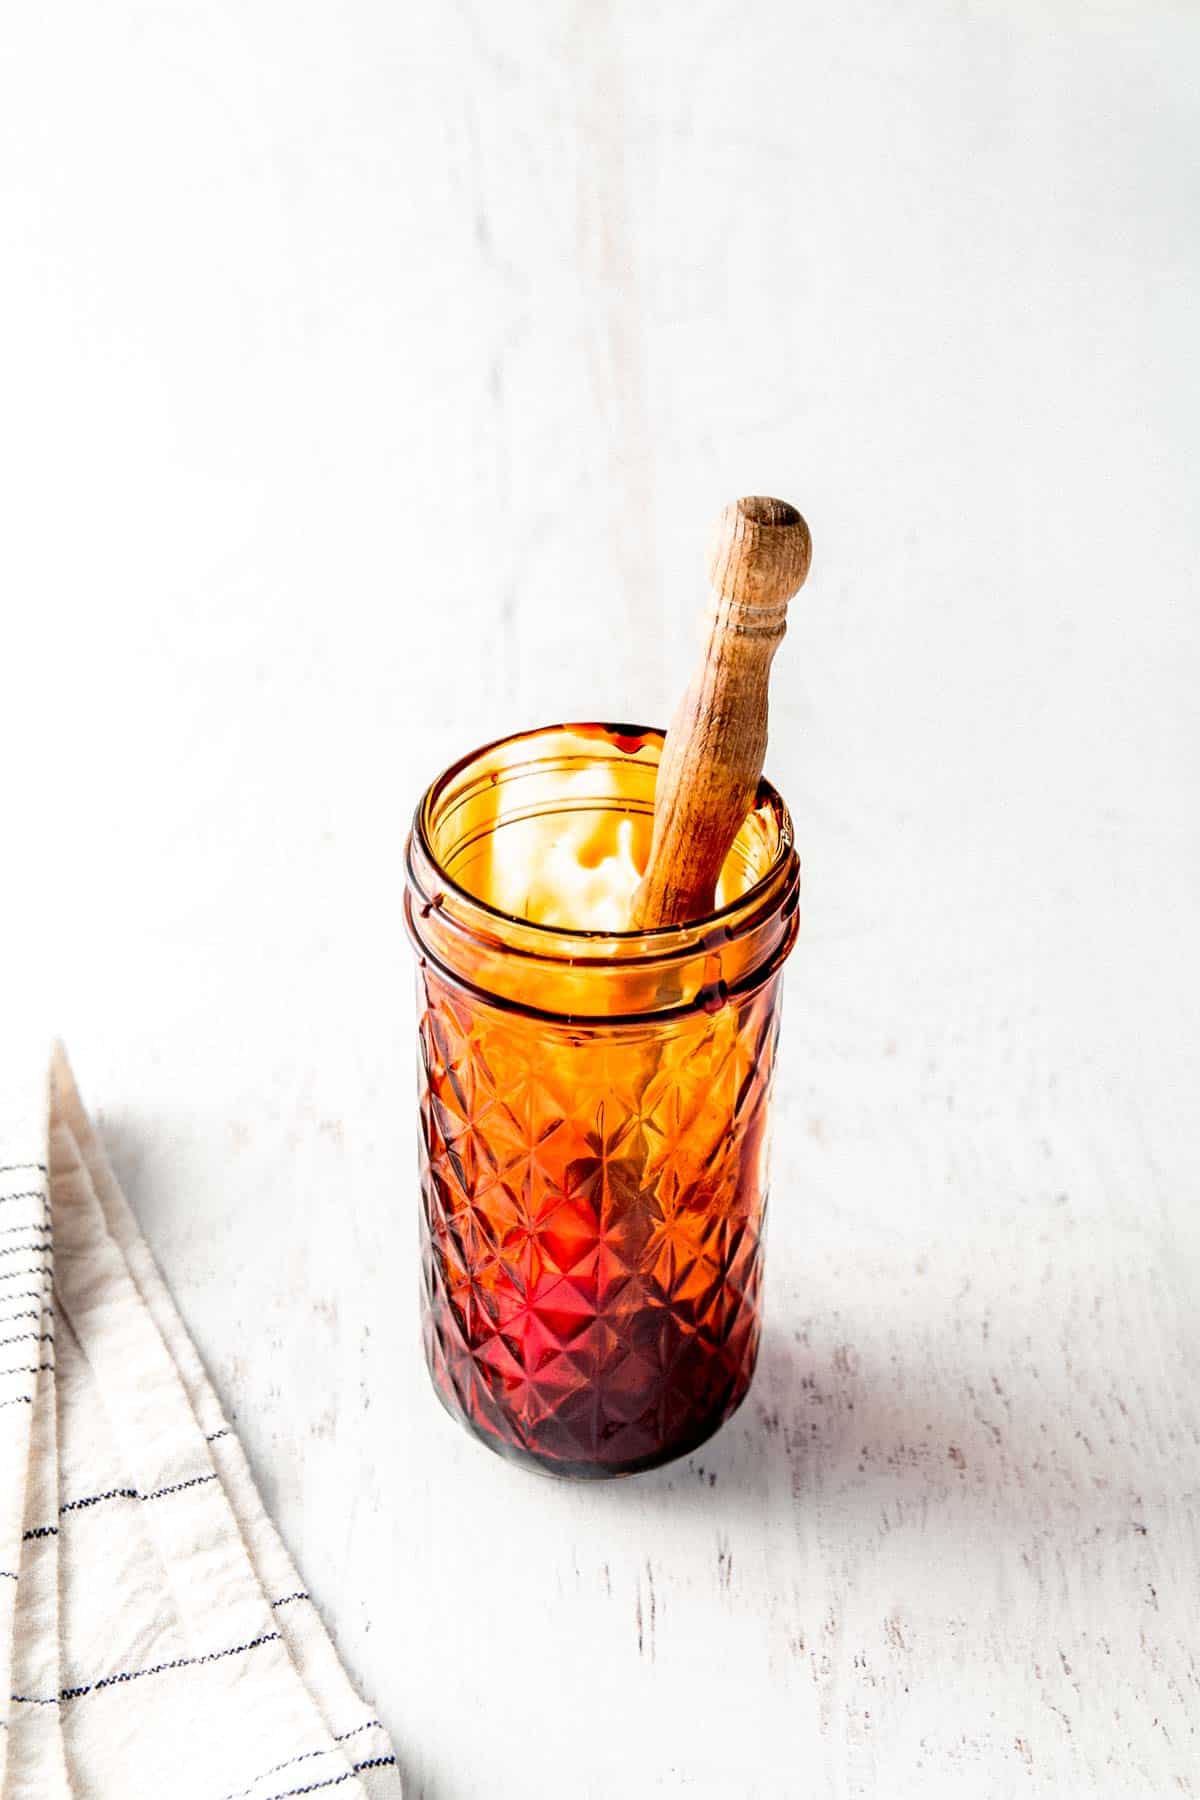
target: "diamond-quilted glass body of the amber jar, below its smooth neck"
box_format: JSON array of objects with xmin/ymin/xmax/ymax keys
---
[{"xmin": 421, "ymin": 968, "xmax": 779, "ymax": 1474}]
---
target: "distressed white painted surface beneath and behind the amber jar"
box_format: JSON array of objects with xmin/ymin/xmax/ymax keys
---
[{"xmin": 0, "ymin": 0, "xmax": 1200, "ymax": 1800}]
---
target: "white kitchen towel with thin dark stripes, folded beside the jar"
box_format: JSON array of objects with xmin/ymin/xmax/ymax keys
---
[{"xmin": 0, "ymin": 1053, "xmax": 399, "ymax": 1800}]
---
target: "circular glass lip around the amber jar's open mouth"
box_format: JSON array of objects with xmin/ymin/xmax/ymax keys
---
[{"xmin": 408, "ymin": 722, "xmax": 795, "ymax": 963}]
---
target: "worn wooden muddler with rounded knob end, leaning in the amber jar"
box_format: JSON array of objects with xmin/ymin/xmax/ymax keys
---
[{"xmin": 633, "ymin": 499, "xmax": 813, "ymax": 929}]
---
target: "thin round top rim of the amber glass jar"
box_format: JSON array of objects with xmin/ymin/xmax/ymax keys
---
[{"xmin": 412, "ymin": 720, "xmax": 795, "ymax": 956}]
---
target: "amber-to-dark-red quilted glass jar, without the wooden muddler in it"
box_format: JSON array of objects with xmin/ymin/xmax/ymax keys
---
[{"xmin": 405, "ymin": 725, "xmax": 799, "ymax": 1478}]
